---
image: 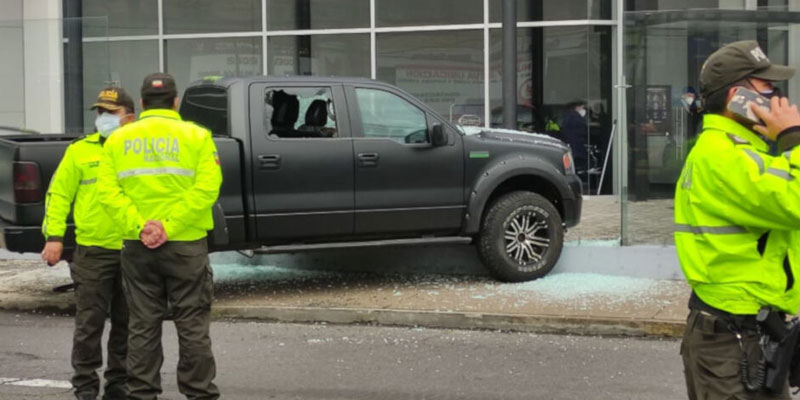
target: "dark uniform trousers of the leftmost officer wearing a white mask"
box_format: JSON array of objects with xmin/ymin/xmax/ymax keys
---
[{"xmin": 70, "ymin": 246, "xmax": 128, "ymax": 399}]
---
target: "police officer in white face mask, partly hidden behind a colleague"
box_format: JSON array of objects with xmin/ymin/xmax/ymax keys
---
[{"xmin": 42, "ymin": 87, "xmax": 134, "ymax": 400}]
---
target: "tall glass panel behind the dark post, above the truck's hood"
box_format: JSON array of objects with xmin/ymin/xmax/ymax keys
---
[{"xmin": 489, "ymin": 26, "xmax": 613, "ymax": 198}]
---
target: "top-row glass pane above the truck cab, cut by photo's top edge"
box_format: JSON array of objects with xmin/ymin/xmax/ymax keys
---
[{"xmin": 267, "ymin": 0, "xmax": 369, "ymax": 31}]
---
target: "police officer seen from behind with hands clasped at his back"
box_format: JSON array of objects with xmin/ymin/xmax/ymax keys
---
[{"xmin": 98, "ymin": 73, "xmax": 222, "ymax": 399}]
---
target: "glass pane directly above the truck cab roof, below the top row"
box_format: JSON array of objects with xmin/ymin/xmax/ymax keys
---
[{"xmin": 267, "ymin": 34, "xmax": 370, "ymax": 77}]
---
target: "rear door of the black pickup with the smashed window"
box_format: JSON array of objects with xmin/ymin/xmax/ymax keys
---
[{"xmin": 250, "ymin": 83, "xmax": 354, "ymax": 242}]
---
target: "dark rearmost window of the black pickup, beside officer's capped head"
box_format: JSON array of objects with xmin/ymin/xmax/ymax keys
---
[{"xmin": 180, "ymin": 86, "xmax": 230, "ymax": 136}]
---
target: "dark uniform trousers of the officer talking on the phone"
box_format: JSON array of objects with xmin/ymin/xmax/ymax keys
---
[{"xmin": 681, "ymin": 310, "xmax": 791, "ymax": 400}]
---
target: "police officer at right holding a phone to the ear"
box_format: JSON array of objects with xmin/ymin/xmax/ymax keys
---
[{"xmin": 675, "ymin": 41, "xmax": 800, "ymax": 400}]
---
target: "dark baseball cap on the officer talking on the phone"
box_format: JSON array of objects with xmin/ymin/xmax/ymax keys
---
[{"xmin": 700, "ymin": 40, "xmax": 795, "ymax": 96}]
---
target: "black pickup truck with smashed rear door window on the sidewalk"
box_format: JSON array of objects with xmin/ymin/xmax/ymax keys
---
[{"xmin": 0, "ymin": 77, "xmax": 582, "ymax": 281}]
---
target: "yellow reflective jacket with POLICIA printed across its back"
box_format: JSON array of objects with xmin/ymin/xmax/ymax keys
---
[{"xmin": 98, "ymin": 109, "xmax": 222, "ymax": 241}]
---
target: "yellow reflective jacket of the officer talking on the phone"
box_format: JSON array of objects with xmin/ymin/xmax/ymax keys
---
[{"xmin": 675, "ymin": 114, "xmax": 800, "ymax": 314}]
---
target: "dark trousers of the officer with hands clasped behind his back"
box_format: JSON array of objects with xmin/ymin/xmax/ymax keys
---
[{"xmin": 122, "ymin": 239, "xmax": 219, "ymax": 400}]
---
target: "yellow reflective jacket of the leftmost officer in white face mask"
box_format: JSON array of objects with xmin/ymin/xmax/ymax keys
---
[{"xmin": 42, "ymin": 133, "xmax": 122, "ymax": 250}]
